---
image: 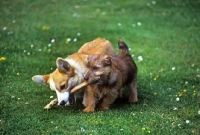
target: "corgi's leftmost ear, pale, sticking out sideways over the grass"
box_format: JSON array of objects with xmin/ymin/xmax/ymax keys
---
[{"xmin": 32, "ymin": 75, "xmax": 50, "ymax": 85}]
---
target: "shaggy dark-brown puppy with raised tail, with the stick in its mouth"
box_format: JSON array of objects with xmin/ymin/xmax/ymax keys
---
[{"xmin": 71, "ymin": 41, "xmax": 138, "ymax": 112}]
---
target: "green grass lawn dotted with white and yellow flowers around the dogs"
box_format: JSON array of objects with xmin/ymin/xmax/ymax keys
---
[{"xmin": 0, "ymin": 0, "xmax": 200, "ymax": 135}]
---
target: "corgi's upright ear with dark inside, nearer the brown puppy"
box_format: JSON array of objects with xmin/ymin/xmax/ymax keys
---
[{"xmin": 56, "ymin": 58, "xmax": 71, "ymax": 74}]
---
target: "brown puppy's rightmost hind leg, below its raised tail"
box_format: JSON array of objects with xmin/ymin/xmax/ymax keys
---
[{"xmin": 128, "ymin": 80, "xmax": 138, "ymax": 103}]
